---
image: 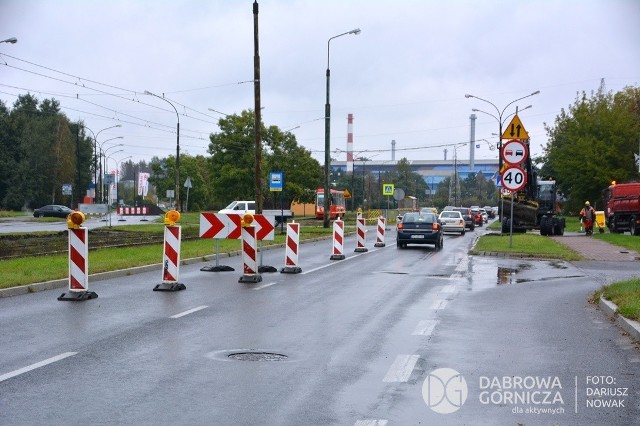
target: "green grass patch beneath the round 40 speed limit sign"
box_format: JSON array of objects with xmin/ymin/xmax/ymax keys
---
[{"xmin": 470, "ymin": 234, "xmax": 582, "ymax": 260}]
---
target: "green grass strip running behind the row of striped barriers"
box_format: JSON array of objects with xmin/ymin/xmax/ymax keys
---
[{"xmin": 0, "ymin": 222, "xmax": 333, "ymax": 288}]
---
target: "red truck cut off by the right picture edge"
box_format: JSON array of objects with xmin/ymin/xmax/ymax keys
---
[{"xmin": 603, "ymin": 182, "xmax": 640, "ymax": 235}]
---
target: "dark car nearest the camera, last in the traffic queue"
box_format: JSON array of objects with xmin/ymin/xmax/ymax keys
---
[{"xmin": 396, "ymin": 212, "xmax": 444, "ymax": 250}]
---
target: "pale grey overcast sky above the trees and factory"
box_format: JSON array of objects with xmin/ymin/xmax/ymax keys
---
[{"xmin": 0, "ymin": 0, "xmax": 640, "ymax": 169}]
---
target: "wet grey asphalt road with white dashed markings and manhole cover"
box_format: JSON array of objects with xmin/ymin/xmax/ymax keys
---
[{"xmin": 0, "ymin": 225, "xmax": 640, "ymax": 425}]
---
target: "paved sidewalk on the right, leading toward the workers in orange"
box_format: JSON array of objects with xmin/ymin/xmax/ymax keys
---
[{"xmin": 550, "ymin": 232, "xmax": 640, "ymax": 262}]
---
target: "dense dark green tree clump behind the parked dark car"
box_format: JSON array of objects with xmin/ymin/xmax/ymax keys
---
[{"xmin": 0, "ymin": 94, "xmax": 91, "ymax": 210}]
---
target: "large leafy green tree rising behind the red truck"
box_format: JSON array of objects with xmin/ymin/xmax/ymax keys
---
[{"xmin": 540, "ymin": 87, "xmax": 640, "ymax": 212}]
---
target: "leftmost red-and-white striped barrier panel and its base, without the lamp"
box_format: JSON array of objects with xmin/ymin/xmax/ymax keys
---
[{"xmin": 58, "ymin": 227, "xmax": 98, "ymax": 300}]
